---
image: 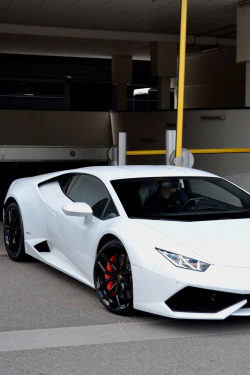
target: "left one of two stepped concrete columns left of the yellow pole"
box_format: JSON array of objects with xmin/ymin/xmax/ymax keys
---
[{"xmin": 112, "ymin": 55, "xmax": 132, "ymax": 110}]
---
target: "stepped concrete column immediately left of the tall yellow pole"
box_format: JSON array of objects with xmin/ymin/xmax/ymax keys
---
[{"xmin": 151, "ymin": 42, "xmax": 177, "ymax": 109}]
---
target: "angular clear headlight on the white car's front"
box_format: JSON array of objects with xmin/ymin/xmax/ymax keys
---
[{"xmin": 156, "ymin": 247, "xmax": 210, "ymax": 272}]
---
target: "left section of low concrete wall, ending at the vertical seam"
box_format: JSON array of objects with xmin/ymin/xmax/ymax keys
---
[{"xmin": 0, "ymin": 110, "xmax": 112, "ymax": 146}]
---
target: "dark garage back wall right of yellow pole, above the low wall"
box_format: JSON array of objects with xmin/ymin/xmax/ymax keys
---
[{"xmin": 180, "ymin": 48, "xmax": 246, "ymax": 108}]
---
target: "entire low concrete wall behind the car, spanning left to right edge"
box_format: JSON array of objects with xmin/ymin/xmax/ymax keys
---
[{"xmin": 0, "ymin": 108, "xmax": 250, "ymax": 182}]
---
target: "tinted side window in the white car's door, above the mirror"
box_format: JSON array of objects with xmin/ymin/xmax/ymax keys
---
[{"xmin": 61, "ymin": 174, "xmax": 118, "ymax": 220}]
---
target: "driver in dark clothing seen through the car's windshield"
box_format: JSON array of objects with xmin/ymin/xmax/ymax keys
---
[{"xmin": 144, "ymin": 178, "xmax": 187, "ymax": 214}]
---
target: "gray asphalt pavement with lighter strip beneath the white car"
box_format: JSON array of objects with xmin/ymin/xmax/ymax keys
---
[{"xmin": 0, "ymin": 223, "xmax": 250, "ymax": 375}]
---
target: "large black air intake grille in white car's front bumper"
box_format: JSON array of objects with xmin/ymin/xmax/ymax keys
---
[{"xmin": 165, "ymin": 287, "xmax": 250, "ymax": 313}]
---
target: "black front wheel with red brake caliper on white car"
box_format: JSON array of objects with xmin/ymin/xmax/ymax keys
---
[{"xmin": 94, "ymin": 240, "xmax": 133, "ymax": 315}]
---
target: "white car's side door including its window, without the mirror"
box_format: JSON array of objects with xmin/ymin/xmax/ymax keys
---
[{"xmin": 57, "ymin": 174, "xmax": 118, "ymax": 280}]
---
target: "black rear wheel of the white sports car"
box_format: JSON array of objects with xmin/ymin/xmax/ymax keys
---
[{"xmin": 4, "ymin": 202, "xmax": 28, "ymax": 262}]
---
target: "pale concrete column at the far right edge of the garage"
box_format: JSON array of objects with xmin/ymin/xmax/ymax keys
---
[{"xmin": 237, "ymin": 1, "xmax": 250, "ymax": 107}]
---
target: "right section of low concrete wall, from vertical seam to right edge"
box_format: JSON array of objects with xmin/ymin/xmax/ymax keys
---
[{"xmin": 111, "ymin": 109, "xmax": 250, "ymax": 176}]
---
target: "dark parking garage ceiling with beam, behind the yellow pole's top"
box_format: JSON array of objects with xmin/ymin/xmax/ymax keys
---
[{"xmin": 0, "ymin": 0, "xmax": 238, "ymax": 60}]
